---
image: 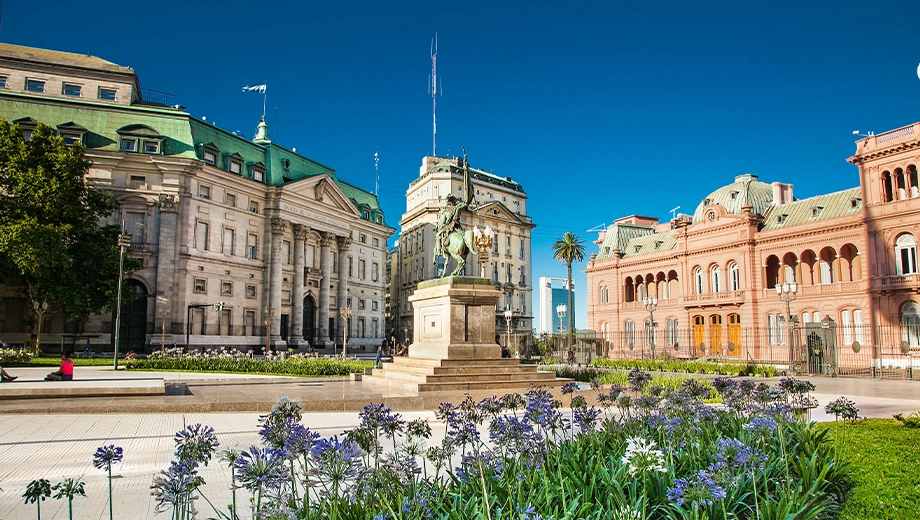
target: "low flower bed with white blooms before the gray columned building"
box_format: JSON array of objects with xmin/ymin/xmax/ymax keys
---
[{"xmin": 125, "ymin": 348, "xmax": 374, "ymax": 377}]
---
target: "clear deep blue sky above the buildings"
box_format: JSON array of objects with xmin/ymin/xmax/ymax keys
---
[{"xmin": 0, "ymin": 0, "xmax": 920, "ymax": 327}]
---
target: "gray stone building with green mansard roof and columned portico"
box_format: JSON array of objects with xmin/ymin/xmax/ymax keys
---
[{"xmin": 0, "ymin": 44, "xmax": 394, "ymax": 352}]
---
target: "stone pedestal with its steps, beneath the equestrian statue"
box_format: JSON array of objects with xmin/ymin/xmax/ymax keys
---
[{"xmin": 363, "ymin": 276, "xmax": 569, "ymax": 392}]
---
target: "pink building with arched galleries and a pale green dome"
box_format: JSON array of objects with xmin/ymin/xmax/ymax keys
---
[{"xmin": 586, "ymin": 123, "xmax": 920, "ymax": 371}]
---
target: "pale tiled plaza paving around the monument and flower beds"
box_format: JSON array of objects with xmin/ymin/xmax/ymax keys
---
[{"xmin": 0, "ymin": 367, "xmax": 920, "ymax": 520}]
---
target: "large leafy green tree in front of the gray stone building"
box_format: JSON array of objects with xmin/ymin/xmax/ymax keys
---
[{"xmin": 0, "ymin": 120, "xmax": 139, "ymax": 334}]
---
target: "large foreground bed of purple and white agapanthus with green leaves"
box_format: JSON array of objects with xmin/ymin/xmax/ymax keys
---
[{"xmin": 133, "ymin": 373, "xmax": 847, "ymax": 520}]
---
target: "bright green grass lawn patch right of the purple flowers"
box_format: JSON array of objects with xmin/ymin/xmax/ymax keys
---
[{"xmin": 819, "ymin": 419, "xmax": 920, "ymax": 520}]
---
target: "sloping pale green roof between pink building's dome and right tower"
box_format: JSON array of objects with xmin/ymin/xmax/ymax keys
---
[{"xmin": 760, "ymin": 188, "xmax": 862, "ymax": 232}]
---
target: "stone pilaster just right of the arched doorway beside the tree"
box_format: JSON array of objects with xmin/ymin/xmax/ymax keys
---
[{"xmin": 150, "ymin": 195, "xmax": 179, "ymax": 344}]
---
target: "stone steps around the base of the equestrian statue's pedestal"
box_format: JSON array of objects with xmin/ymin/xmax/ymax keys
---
[{"xmin": 362, "ymin": 357, "xmax": 571, "ymax": 392}]
